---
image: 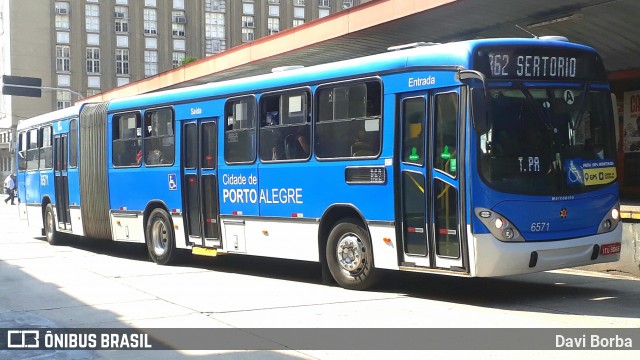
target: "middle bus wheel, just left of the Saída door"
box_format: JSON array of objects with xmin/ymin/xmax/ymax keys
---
[{"xmin": 145, "ymin": 209, "xmax": 177, "ymax": 265}]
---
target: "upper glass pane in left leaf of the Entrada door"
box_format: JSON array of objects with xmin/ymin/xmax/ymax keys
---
[{"xmin": 402, "ymin": 97, "xmax": 426, "ymax": 165}]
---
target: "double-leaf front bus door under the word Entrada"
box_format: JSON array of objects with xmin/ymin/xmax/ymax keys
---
[{"xmin": 400, "ymin": 90, "xmax": 466, "ymax": 271}]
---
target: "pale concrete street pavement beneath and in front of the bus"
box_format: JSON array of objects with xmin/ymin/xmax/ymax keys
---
[{"xmin": 0, "ymin": 202, "xmax": 640, "ymax": 359}]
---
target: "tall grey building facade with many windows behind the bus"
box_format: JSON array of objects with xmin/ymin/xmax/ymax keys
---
[{"xmin": 0, "ymin": 0, "xmax": 370, "ymax": 178}]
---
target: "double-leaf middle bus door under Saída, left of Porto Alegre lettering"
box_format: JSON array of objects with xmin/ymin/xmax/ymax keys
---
[{"xmin": 182, "ymin": 118, "xmax": 222, "ymax": 248}]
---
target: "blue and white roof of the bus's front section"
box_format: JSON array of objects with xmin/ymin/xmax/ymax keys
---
[{"xmin": 108, "ymin": 38, "xmax": 593, "ymax": 112}]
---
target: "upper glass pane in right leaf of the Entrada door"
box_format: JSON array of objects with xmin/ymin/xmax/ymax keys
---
[{"xmin": 433, "ymin": 92, "xmax": 458, "ymax": 177}]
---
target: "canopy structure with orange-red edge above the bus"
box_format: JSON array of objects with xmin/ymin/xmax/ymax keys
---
[{"xmin": 88, "ymin": 0, "xmax": 640, "ymax": 101}]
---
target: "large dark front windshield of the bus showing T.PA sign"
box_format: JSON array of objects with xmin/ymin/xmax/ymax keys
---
[{"xmin": 478, "ymin": 85, "xmax": 616, "ymax": 196}]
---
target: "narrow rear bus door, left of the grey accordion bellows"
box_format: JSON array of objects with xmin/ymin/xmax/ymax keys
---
[{"xmin": 53, "ymin": 134, "xmax": 71, "ymax": 231}]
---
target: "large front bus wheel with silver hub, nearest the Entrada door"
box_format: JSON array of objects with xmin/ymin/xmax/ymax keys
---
[{"xmin": 326, "ymin": 218, "xmax": 378, "ymax": 290}]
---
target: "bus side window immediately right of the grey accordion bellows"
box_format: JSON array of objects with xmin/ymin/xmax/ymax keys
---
[{"xmin": 112, "ymin": 113, "xmax": 142, "ymax": 167}]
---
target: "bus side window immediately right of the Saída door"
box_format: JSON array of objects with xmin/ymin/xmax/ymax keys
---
[{"xmin": 224, "ymin": 97, "xmax": 256, "ymax": 164}]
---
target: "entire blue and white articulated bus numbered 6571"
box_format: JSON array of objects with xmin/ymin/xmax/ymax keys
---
[{"xmin": 17, "ymin": 38, "xmax": 621, "ymax": 289}]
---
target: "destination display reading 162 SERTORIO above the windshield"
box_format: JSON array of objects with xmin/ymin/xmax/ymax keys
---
[{"xmin": 474, "ymin": 46, "xmax": 606, "ymax": 81}]
